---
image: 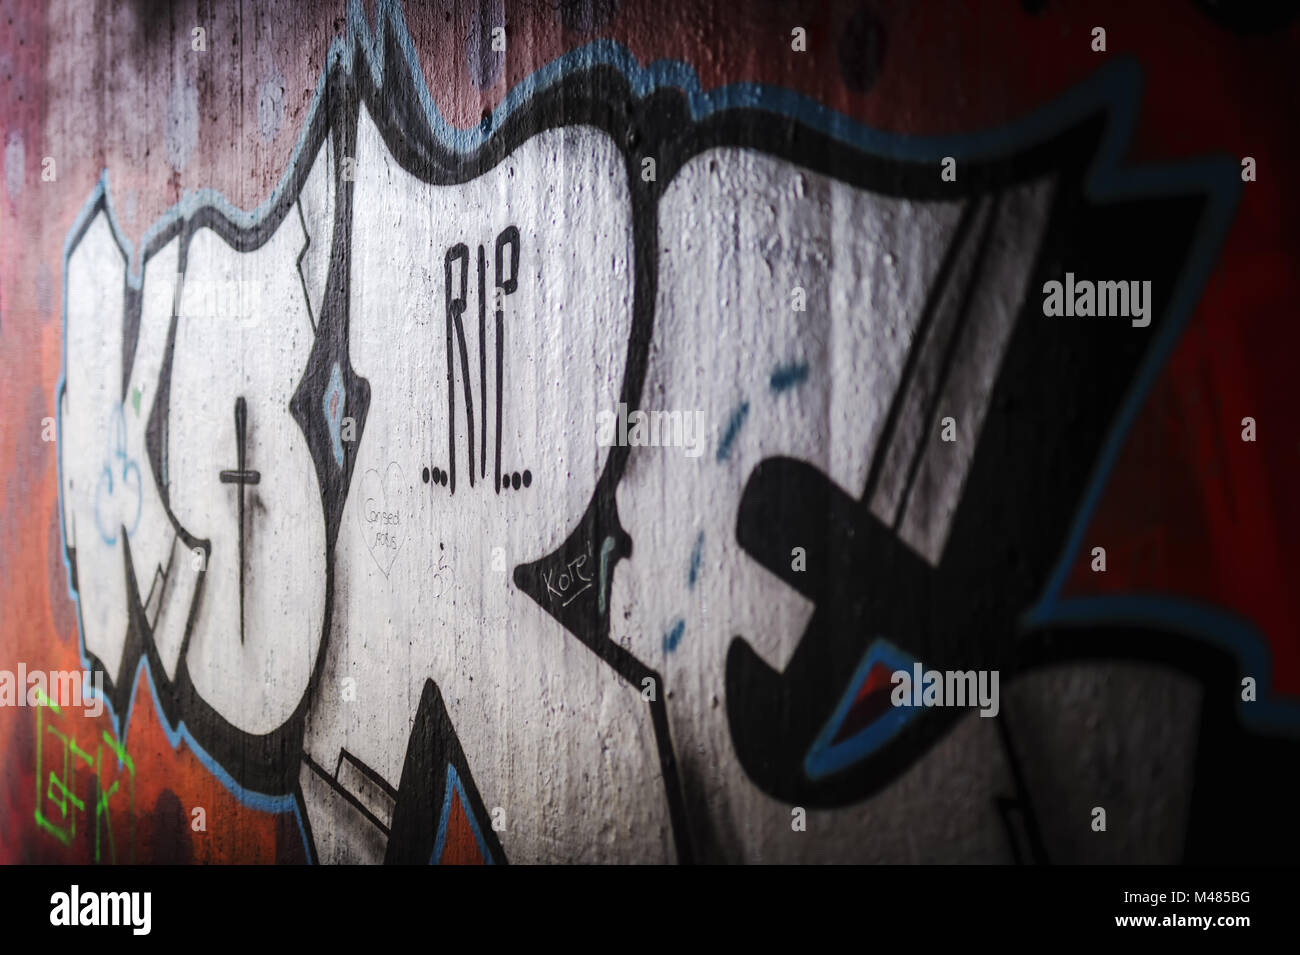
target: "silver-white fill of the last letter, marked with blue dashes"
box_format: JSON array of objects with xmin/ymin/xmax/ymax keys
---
[{"xmin": 610, "ymin": 151, "xmax": 961, "ymax": 860}]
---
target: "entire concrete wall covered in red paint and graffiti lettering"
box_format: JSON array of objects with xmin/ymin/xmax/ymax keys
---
[{"xmin": 0, "ymin": 0, "xmax": 1300, "ymax": 863}]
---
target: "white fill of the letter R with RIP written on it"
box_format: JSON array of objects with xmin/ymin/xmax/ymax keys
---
[{"xmin": 306, "ymin": 104, "xmax": 672, "ymax": 861}]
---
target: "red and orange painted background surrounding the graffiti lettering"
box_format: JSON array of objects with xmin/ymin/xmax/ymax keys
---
[{"xmin": 0, "ymin": 0, "xmax": 1300, "ymax": 863}]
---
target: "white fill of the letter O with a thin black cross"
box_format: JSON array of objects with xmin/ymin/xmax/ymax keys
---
[{"xmin": 168, "ymin": 216, "xmax": 325, "ymax": 733}]
